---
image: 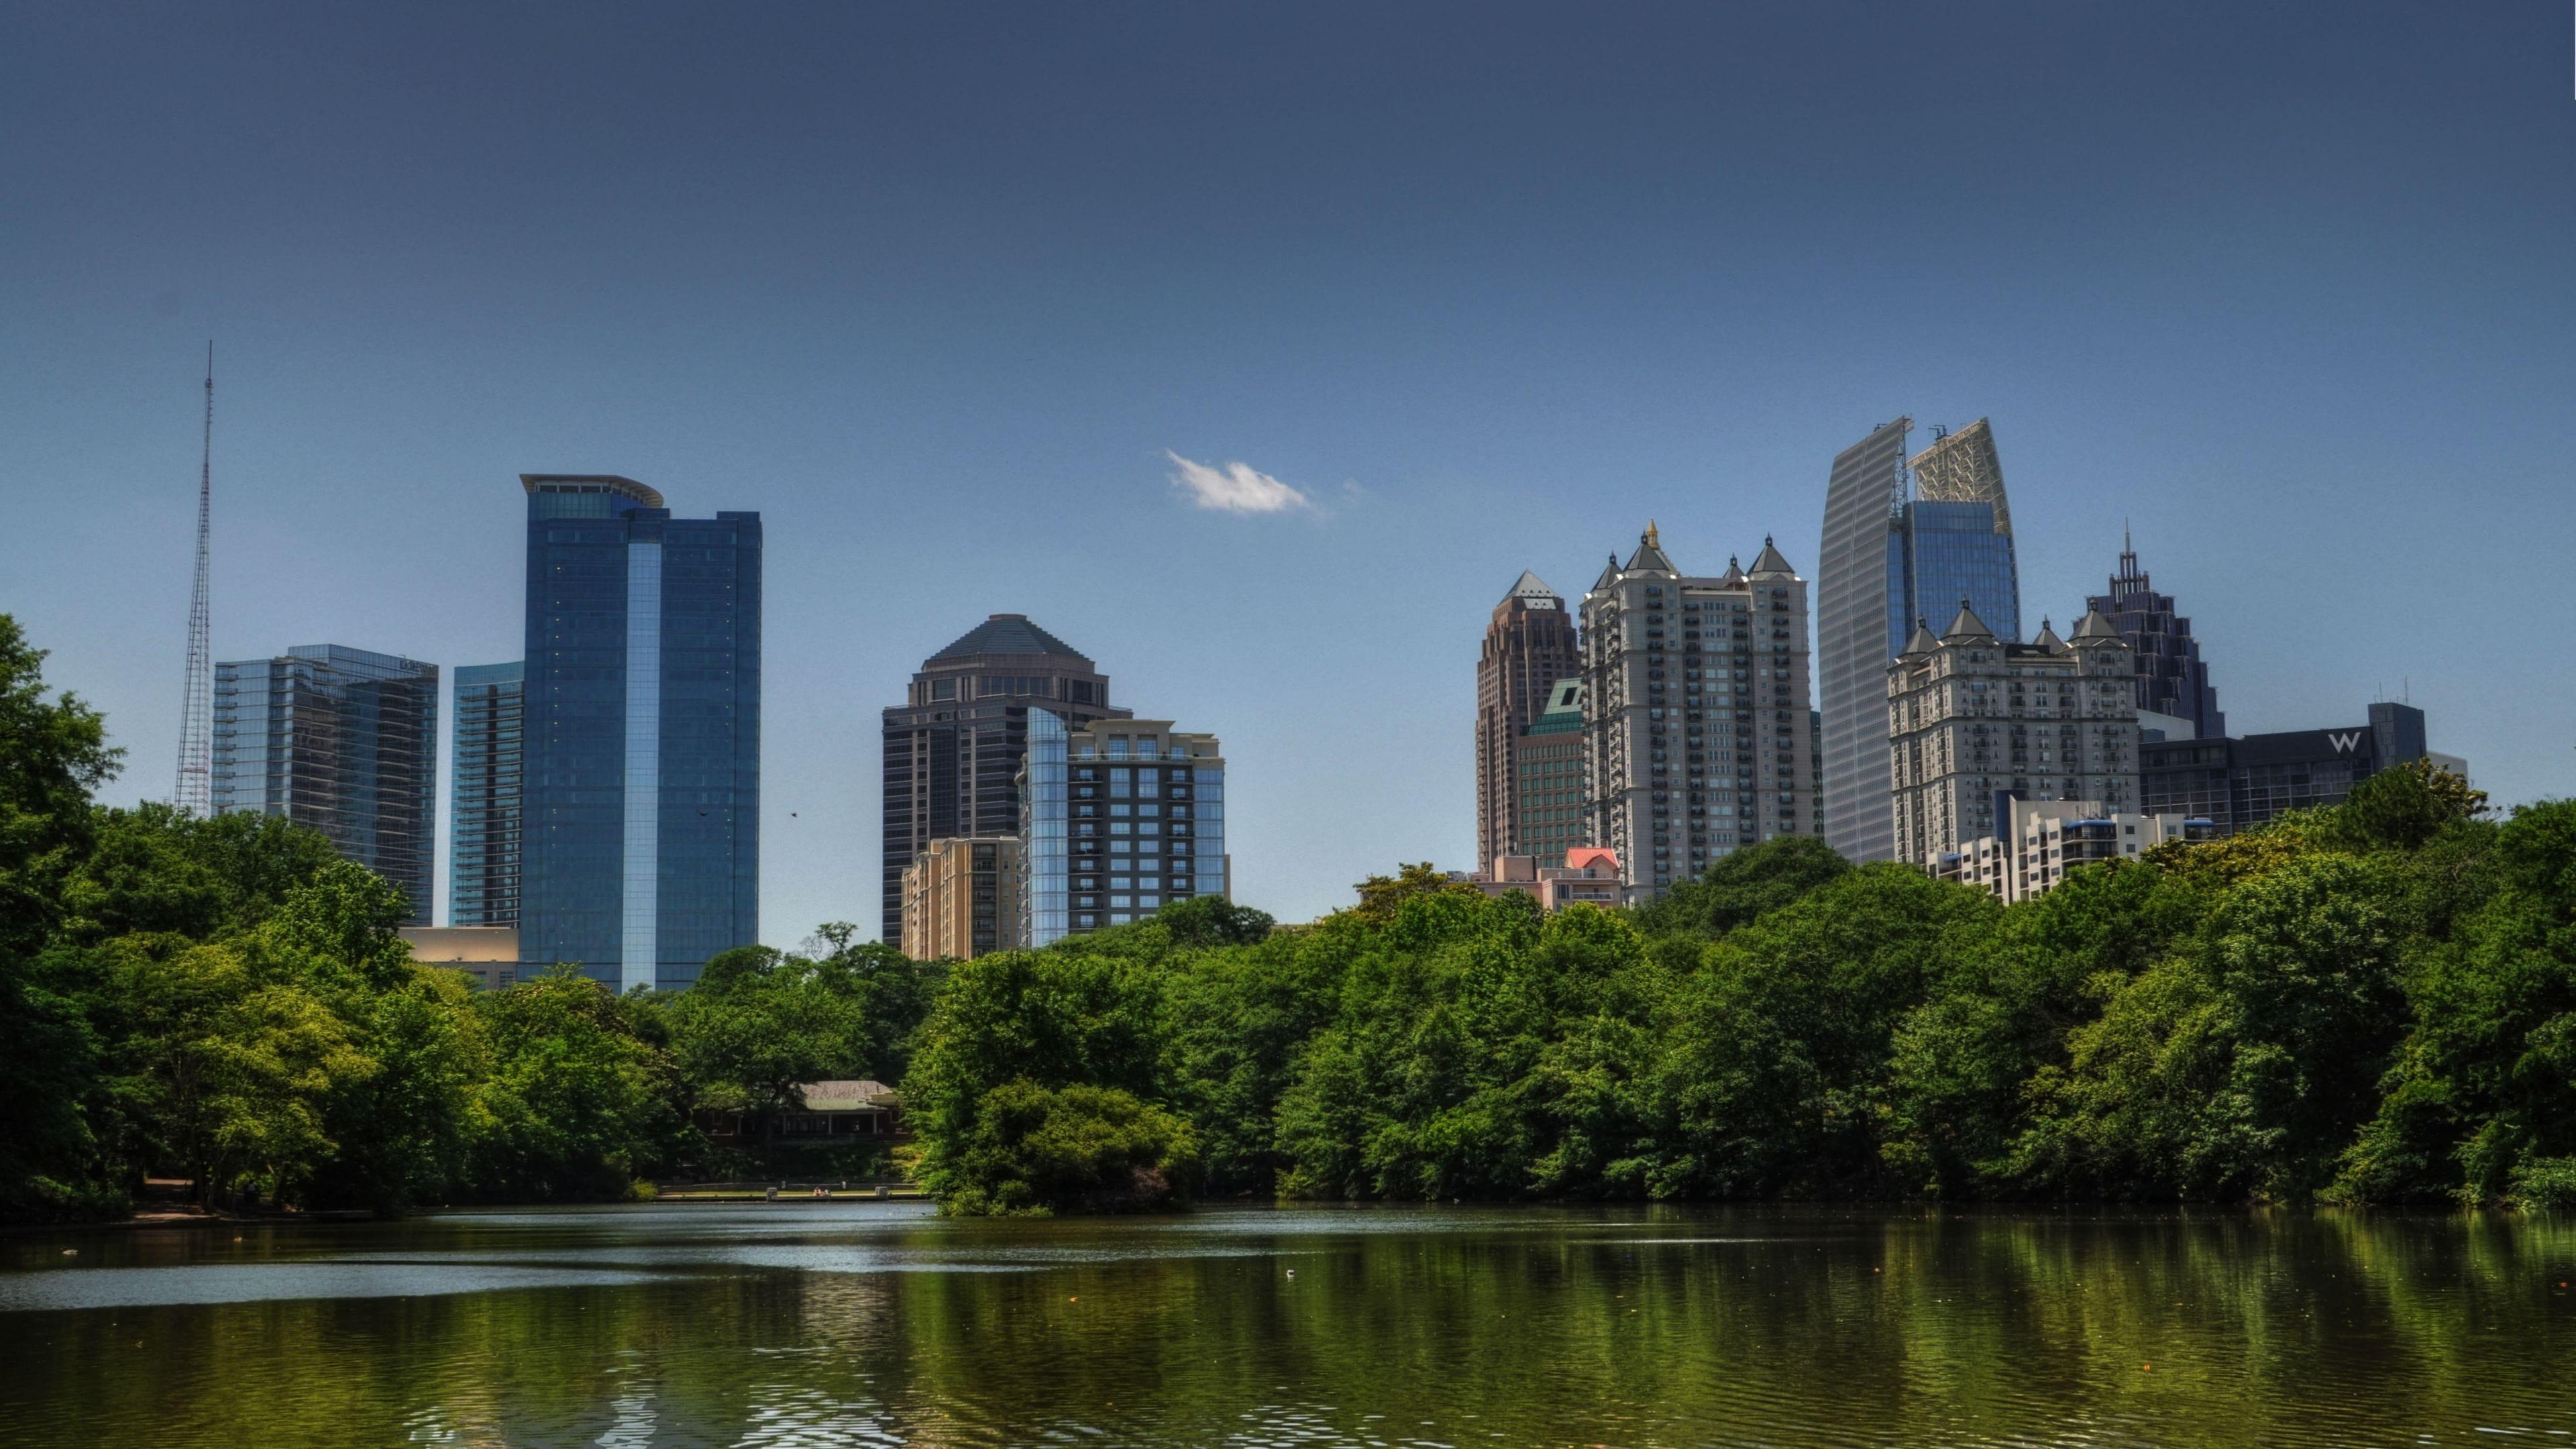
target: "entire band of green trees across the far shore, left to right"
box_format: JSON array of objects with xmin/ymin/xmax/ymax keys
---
[{"xmin": 0, "ymin": 616, "xmax": 2576, "ymax": 1214}]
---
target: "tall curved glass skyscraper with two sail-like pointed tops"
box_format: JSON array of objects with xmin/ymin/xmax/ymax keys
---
[{"xmin": 1816, "ymin": 418, "xmax": 2022, "ymax": 861}]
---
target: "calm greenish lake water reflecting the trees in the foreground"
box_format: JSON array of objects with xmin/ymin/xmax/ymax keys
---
[{"xmin": 0, "ymin": 1201, "xmax": 2576, "ymax": 1449}]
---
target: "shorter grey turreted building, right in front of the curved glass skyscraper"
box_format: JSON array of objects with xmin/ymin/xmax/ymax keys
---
[{"xmin": 1886, "ymin": 603, "xmax": 2141, "ymax": 866}]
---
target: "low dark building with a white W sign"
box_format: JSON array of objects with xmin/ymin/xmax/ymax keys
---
[{"xmin": 2138, "ymin": 701, "xmax": 2468, "ymax": 835}]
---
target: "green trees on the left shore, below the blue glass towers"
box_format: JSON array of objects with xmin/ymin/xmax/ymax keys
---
[{"xmin": 0, "ymin": 616, "xmax": 938, "ymax": 1217}]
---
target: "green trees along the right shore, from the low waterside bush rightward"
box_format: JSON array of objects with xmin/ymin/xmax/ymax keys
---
[{"xmin": 907, "ymin": 768, "xmax": 2576, "ymax": 1212}]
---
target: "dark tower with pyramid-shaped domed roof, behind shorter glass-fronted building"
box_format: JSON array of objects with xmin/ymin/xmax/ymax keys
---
[{"xmin": 878, "ymin": 614, "xmax": 1128, "ymax": 944}]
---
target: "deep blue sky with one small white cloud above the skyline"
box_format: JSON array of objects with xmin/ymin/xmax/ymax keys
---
[{"xmin": 0, "ymin": 3, "xmax": 2576, "ymax": 947}]
